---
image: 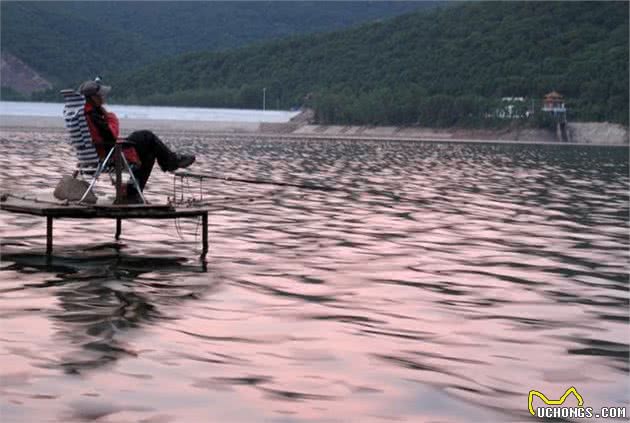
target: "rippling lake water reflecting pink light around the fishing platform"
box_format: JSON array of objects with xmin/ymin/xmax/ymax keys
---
[{"xmin": 0, "ymin": 131, "xmax": 630, "ymax": 423}]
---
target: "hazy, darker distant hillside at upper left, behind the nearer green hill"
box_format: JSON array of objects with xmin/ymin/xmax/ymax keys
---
[{"xmin": 0, "ymin": 1, "xmax": 432, "ymax": 89}]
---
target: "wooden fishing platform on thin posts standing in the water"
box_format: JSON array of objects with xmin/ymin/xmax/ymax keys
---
[{"xmin": 0, "ymin": 194, "xmax": 208, "ymax": 258}]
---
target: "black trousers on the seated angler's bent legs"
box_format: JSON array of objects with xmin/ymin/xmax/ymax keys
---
[{"xmin": 127, "ymin": 131, "xmax": 177, "ymax": 191}]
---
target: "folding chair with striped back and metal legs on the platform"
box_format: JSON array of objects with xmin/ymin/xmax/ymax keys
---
[{"xmin": 61, "ymin": 90, "xmax": 146, "ymax": 204}]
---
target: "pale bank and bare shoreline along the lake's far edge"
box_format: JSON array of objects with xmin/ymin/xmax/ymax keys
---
[{"xmin": 0, "ymin": 115, "xmax": 628, "ymax": 147}]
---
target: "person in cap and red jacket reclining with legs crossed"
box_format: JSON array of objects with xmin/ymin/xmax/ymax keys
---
[{"xmin": 79, "ymin": 78, "xmax": 195, "ymax": 202}]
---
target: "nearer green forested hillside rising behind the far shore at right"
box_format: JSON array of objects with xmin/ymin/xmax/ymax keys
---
[{"xmin": 103, "ymin": 2, "xmax": 628, "ymax": 126}]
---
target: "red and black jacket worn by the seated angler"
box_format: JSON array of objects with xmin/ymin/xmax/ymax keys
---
[{"xmin": 84, "ymin": 103, "xmax": 140, "ymax": 164}]
